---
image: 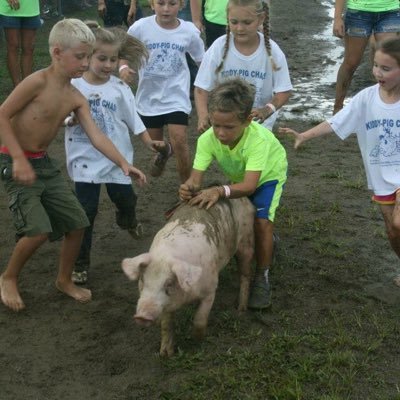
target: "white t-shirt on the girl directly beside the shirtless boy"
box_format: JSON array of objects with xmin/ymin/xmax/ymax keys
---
[{"xmin": 65, "ymin": 76, "xmax": 146, "ymax": 184}]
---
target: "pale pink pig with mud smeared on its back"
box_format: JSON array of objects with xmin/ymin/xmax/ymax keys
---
[{"xmin": 122, "ymin": 197, "xmax": 255, "ymax": 356}]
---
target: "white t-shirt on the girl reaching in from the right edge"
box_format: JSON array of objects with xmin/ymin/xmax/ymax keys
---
[{"xmin": 328, "ymin": 84, "xmax": 400, "ymax": 196}]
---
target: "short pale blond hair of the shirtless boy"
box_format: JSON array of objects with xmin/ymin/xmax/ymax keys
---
[{"xmin": 49, "ymin": 18, "xmax": 96, "ymax": 50}]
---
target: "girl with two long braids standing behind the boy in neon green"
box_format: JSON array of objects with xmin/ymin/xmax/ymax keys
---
[{"xmin": 194, "ymin": 0, "xmax": 292, "ymax": 132}]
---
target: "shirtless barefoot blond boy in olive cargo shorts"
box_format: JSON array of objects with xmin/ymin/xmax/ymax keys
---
[{"xmin": 0, "ymin": 19, "xmax": 146, "ymax": 311}]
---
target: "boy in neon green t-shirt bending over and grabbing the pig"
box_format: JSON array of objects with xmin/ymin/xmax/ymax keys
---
[{"xmin": 179, "ymin": 78, "xmax": 287, "ymax": 309}]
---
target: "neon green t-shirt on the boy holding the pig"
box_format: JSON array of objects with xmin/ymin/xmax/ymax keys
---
[{"xmin": 193, "ymin": 122, "xmax": 287, "ymax": 187}]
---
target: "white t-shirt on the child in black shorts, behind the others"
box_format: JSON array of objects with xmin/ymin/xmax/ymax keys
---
[{"xmin": 128, "ymin": 15, "xmax": 204, "ymax": 116}]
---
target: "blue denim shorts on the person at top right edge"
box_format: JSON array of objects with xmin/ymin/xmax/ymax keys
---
[{"xmin": 344, "ymin": 9, "xmax": 400, "ymax": 38}]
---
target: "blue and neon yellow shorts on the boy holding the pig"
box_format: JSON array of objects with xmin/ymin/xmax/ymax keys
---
[{"xmin": 249, "ymin": 180, "xmax": 285, "ymax": 222}]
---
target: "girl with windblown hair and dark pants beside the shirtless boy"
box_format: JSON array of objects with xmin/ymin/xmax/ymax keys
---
[{"xmin": 65, "ymin": 21, "xmax": 165, "ymax": 284}]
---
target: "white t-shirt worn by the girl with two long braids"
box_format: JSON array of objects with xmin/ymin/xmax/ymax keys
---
[{"xmin": 194, "ymin": 33, "xmax": 293, "ymax": 129}]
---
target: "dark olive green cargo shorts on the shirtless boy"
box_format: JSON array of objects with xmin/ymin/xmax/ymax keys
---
[{"xmin": 0, "ymin": 154, "xmax": 89, "ymax": 240}]
